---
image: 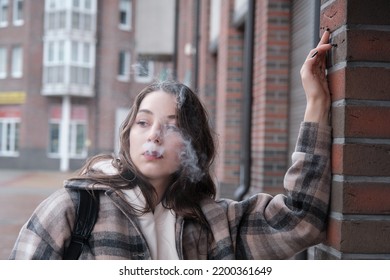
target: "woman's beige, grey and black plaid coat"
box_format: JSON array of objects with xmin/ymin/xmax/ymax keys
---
[{"xmin": 10, "ymin": 123, "xmax": 331, "ymax": 260}]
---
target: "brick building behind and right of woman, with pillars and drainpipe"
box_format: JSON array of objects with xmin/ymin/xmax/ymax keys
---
[{"xmin": 175, "ymin": 0, "xmax": 390, "ymax": 259}]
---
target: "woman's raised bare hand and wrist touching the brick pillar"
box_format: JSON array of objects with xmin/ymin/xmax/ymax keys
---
[{"xmin": 300, "ymin": 31, "xmax": 332, "ymax": 125}]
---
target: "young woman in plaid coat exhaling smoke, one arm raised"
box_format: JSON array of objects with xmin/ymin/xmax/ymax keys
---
[{"xmin": 10, "ymin": 32, "xmax": 331, "ymax": 259}]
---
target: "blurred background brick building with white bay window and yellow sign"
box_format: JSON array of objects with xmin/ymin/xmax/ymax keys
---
[{"xmin": 0, "ymin": 0, "xmax": 173, "ymax": 170}]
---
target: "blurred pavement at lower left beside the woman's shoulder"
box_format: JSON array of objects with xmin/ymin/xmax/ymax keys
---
[{"xmin": 0, "ymin": 169, "xmax": 74, "ymax": 260}]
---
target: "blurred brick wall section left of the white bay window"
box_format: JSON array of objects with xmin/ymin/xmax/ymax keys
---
[{"xmin": 7, "ymin": 1, "xmax": 48, "ymax": 150}]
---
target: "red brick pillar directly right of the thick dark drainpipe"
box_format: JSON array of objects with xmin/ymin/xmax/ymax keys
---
[{"xmin": 251, "ymin": 0, "xmax": 290, "ymax": 196}]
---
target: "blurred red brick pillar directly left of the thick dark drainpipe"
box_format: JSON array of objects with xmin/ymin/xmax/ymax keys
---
[{"xmin": 216, "ymin": 0, "xmax": 244, "ymax": 186}]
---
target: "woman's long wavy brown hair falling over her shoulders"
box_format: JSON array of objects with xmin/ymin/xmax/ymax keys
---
[{"xmin": 72, "ymin": 81, "xmax": 216, "ymax": 224}]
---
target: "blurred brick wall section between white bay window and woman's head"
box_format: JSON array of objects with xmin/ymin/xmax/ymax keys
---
[{"xmin": 93, "ymin": 0, "xmax": 138, "ymax": 153}]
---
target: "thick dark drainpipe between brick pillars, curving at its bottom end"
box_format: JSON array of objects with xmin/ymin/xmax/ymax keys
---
[{"xmin": 234, "ymin": 0, "xmax": 255, "ymax": 200}]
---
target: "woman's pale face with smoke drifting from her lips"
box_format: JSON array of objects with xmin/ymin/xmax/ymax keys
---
[{"xmin": 129, "ymin": 91, "xmax": 183, "ymax": 187}]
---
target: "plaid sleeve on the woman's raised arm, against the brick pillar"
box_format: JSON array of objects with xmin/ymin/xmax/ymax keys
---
[{"xmin": 190, "ymin": 123, "xmax": 331, "ymax": 259}]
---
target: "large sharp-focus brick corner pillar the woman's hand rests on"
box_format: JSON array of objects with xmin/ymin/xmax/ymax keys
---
[{"xmin": 315, "ymin": 0, "xmax": 390, "ymax": 259}]
